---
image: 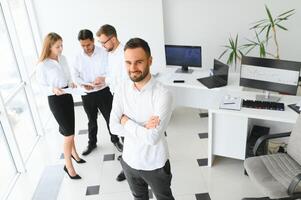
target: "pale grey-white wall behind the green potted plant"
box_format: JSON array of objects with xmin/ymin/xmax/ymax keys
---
[{"xmin": 163, "ymin": 0, "xmax": 301, "ymax": 68}]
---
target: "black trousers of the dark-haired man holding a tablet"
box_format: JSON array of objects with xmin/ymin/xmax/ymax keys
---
[{"xmin": 82, "ymin": 87, "xmax": 119, "ymax": 146}]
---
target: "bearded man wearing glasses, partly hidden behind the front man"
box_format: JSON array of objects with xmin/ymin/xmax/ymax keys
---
[{"xmin": 96, "ymin": 24, "xmax": 128, "ymax": 181}]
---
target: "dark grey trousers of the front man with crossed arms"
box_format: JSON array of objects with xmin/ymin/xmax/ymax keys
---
[{"xmin": 120, "ymin": 159, "xmax": 174, "ymax": 200}]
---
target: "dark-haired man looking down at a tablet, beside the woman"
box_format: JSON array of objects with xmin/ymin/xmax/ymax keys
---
[{"xmin": 73, "ymin": 29, "xmax": 123, "ymax": 155}]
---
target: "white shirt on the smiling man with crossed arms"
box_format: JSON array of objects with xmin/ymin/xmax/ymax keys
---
[{"xmin": 110, "ymin": 77, "xmax": 172, "ymax": 170}]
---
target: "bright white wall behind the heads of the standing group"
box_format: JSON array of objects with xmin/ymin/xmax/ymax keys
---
[{"xmin": 32, "ymin": 0, "xmax": 165, "ymax": 71}]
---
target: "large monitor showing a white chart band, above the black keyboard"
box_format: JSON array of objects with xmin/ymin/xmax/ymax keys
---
[{"xmin": 240, "ymin": 56, "xmax": 301, "ymax": 101}]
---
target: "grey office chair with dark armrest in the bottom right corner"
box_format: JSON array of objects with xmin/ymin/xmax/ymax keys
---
[{"xmin": 243, "ymin": 115, "xmax": 301, "ymax": 200}]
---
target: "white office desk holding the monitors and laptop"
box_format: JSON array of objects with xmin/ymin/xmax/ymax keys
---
[{"xmin": 157, "ymin": 68, "xmax": 301, "ymax": 166}]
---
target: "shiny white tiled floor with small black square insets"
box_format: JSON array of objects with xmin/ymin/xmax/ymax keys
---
[{"xmin": 10, "ymin": 107, "xmax": 262, "ymax": 200}]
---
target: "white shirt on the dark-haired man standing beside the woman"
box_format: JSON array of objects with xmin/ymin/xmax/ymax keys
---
[{"xmin": 73, "ymin": 46, "xmax": 108, "ymax": 92}]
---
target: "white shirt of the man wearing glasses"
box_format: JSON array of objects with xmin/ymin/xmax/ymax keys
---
[{"xmin": 106, "ymin": 43, "xmax": 128, "ymax": 93}]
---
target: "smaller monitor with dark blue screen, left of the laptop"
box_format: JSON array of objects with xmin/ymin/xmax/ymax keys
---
[{"xmin": 165, "ymin": 45, "xmax": 202, "ymax": 73}]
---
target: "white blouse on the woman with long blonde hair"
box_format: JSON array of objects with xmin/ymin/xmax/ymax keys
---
[{"xmin": 36, "ymin": 55, "xmax": 71, "ymax": 96}]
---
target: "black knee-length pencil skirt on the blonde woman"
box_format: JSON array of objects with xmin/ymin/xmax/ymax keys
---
[{"xmin": 48, "ymin": 94, "xmax": 75, "ymax": 136}]
